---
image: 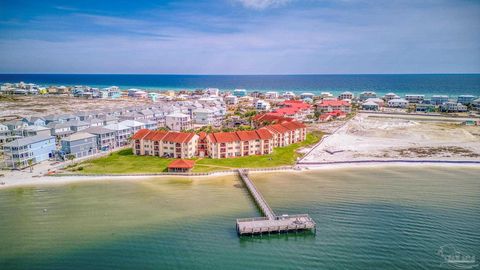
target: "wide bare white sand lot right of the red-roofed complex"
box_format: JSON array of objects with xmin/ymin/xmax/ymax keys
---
[{"xmin": 300, "ymin": 113, "xmax": 480, "ymax": 163}]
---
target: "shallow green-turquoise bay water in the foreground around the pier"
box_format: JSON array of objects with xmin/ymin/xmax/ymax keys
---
[{"xmin": 0, "ymin": 167, "xmax": 480, "ymax": 269}]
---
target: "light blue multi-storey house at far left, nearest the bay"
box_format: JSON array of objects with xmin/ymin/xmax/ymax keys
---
[{"xmin": 3, "ymin": 135, "xmax": 55, "ymax": 169}]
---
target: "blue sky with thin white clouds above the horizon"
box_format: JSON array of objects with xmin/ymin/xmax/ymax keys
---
[{"xmin": 0, "ymin": 0, "xmax": 480, "ymax": 74}]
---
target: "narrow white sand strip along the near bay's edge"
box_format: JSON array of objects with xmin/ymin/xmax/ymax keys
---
[{"xmin": 0, "ymin": 160, "xmax": 480, "ymax": 190}]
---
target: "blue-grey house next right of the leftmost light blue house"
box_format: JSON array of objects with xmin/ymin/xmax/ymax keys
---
[{"xmin": 61, "ymin": 132, "xmax": 98, "ymax": 158}]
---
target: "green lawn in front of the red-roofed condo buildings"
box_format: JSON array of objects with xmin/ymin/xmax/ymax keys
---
[{"xmin": 66, "ymin": 132, "xmax": 323, "ymax": 174}]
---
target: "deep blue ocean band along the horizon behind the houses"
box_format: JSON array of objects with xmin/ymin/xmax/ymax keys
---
[{"xmin": 0, "ymin": 74, "xmax": 480, "ymax": 97}]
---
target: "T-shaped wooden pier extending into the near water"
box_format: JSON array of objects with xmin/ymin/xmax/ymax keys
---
[{"xmin": 237, "ymin": 169, "xmax": 316, "ymax": 235}]
